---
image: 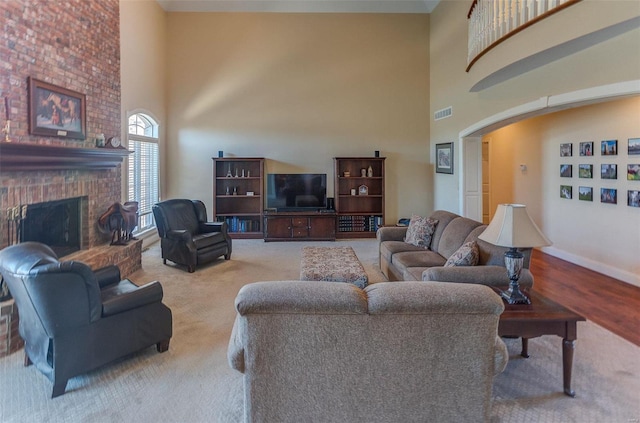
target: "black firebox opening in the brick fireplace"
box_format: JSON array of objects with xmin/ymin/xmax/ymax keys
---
[{"xmin": 20, "ymin": 198, "xmax": 81, "ymax": 257}]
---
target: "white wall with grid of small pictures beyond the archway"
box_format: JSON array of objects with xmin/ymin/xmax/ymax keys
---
[{"xmin": 484, "ymin": 97, "xmax": 640, "ymax": 286}]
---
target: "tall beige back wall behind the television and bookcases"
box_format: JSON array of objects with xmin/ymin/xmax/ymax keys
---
[{"xmin": 165, "ymin": 13, "xmax": 432, "ymax": 223}]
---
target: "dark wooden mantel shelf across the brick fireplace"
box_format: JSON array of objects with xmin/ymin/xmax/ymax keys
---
[{"xmin": 0, "ymin": 142, "xmax": 131, "ymax": 171}]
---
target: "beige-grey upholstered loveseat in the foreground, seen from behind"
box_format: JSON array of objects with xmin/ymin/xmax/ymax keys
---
[{"xmin": 228, "ymin": 281, "xmax": 508, "ymax": 423}]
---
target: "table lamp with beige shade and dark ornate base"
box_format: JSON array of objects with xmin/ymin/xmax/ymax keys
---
[{"xmin": 478, "ymin": 204, "xmax": 551, "ymax": 304}]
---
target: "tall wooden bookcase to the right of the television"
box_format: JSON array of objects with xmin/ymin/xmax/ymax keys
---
[{"xmin": 333, "ymin": 157, "xmax": 385, "ymax": 238}]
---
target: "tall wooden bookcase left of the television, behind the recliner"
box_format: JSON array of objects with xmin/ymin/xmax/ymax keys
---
[{"xmin": 213, "ymin": 157, "xmax": 264, "ymax": 238}]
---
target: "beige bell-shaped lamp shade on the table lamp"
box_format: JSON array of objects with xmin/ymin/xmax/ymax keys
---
[{"xmin": 478, "ymin": 204, "xmax": 551, "ymax": 248}]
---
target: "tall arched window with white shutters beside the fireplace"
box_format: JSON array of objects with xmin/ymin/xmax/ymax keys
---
[{"xmin": 127, "ymin": 113, "xmax": 160, "ymax": 235}]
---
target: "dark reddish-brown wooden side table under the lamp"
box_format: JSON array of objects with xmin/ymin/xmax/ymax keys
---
[{"xmin": 498, "ymin": 291, "xmax": 586, "ymax": 397}]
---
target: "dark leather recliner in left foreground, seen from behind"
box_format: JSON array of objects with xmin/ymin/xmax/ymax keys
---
[{"xmin": 0, "ymin": 242, "xmax": 172, "ymax": 398}]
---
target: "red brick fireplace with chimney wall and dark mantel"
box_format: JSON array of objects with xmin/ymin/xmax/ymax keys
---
[{"xmin": 0, "ymin": 0, "xmax": 124, "ymax": 356}]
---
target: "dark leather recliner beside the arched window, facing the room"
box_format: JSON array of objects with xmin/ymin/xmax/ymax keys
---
[{"xmin": 153, "ymin": 199, "xmax": 231, "ymax": 272}]
